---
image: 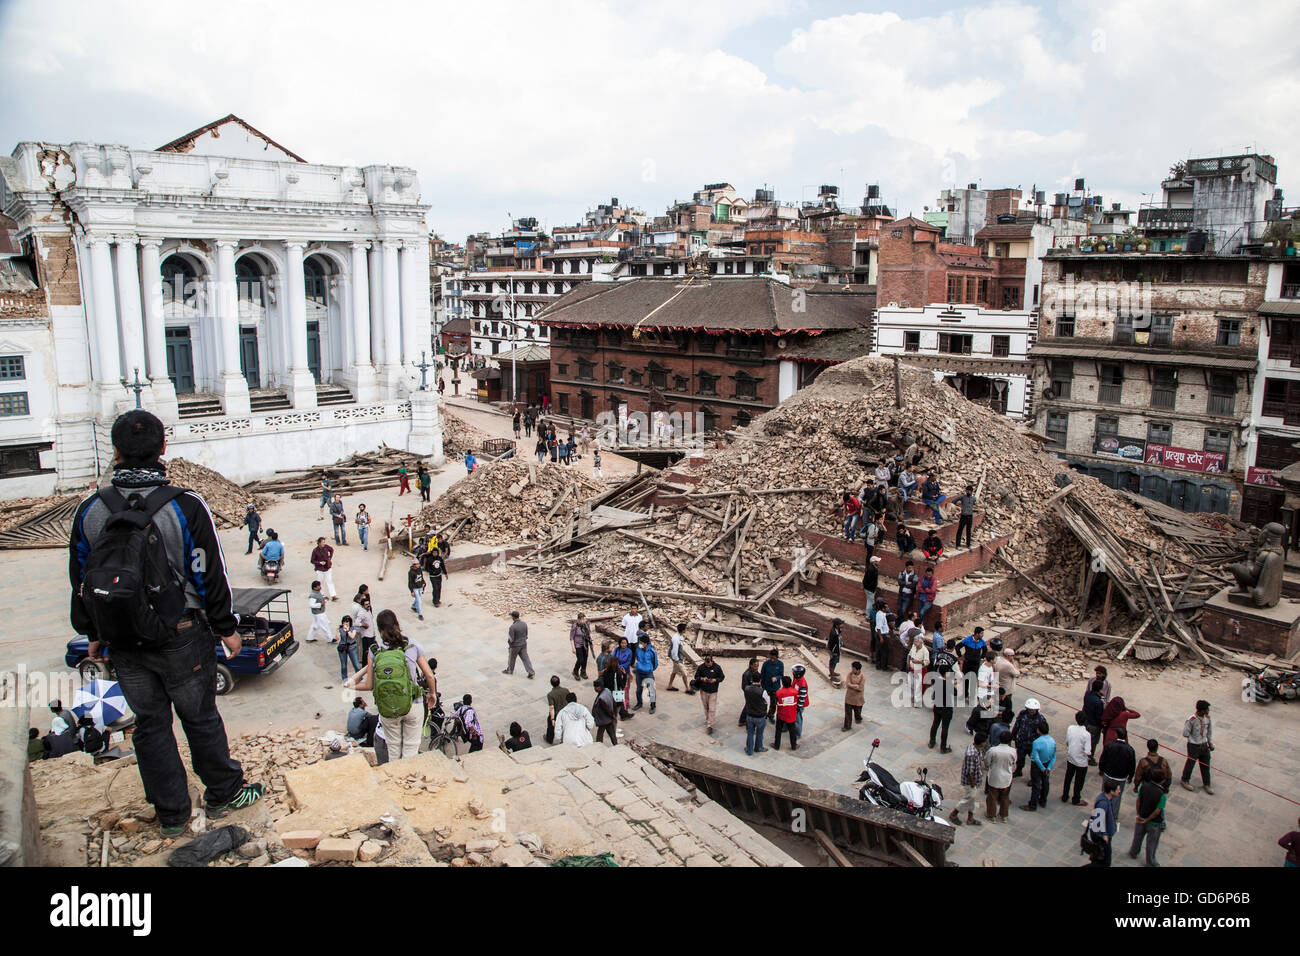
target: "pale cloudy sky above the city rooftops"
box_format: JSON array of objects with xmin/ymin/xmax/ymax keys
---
[{"xmin": 0, "ymin": 0, "xmax": 1300, "ymax": 241}]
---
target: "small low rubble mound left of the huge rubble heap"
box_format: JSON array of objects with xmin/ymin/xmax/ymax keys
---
[{"xmin": 416, "ymin": 458, "xmax": 605, "ymax": 545}]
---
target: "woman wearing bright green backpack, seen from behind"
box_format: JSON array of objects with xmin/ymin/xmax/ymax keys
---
[{"xmin": 343, "ymin": 610, "xmax": 437, "ymax": 760}]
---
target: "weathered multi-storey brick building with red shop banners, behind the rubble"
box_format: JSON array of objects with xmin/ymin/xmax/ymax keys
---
[{"xmin": 1031, "ymin": 250, "xmax": 1268, "ymax": 514}]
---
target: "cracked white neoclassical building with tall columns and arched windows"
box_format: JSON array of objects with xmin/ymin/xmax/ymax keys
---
[{"xmin": 0, "ymin": 116, "xmax": 442, "ymax": 498}]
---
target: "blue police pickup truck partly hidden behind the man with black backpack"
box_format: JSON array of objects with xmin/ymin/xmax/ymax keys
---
[{"xmin": 64, "ymin": 588, "xmax": 298, "ymax": 696}]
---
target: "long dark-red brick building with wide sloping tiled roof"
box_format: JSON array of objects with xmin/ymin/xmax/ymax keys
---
[{"xmin": 537, "ymin": 276, "xmax": 875, "ymax": 431}]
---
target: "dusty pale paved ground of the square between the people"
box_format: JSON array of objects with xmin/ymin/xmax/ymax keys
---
[{"xmin": 0, "ymin": 389, "xmax": 1300, "ymax": 866}]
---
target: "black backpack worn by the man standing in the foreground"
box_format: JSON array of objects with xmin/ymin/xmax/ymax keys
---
[{"xmin": 81, "ymin": 485, "xmax": 188, "ymax": 648}]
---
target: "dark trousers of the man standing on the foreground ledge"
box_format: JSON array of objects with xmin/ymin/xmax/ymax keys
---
[{"xmin": 113, "ymin": 622, "xmax": 244, "ymax": 826}]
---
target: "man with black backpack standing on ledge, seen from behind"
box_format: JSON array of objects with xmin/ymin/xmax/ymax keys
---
[{"xmin": 69, "ymin": 408, "xmax": 264, "ymax": 836}]
